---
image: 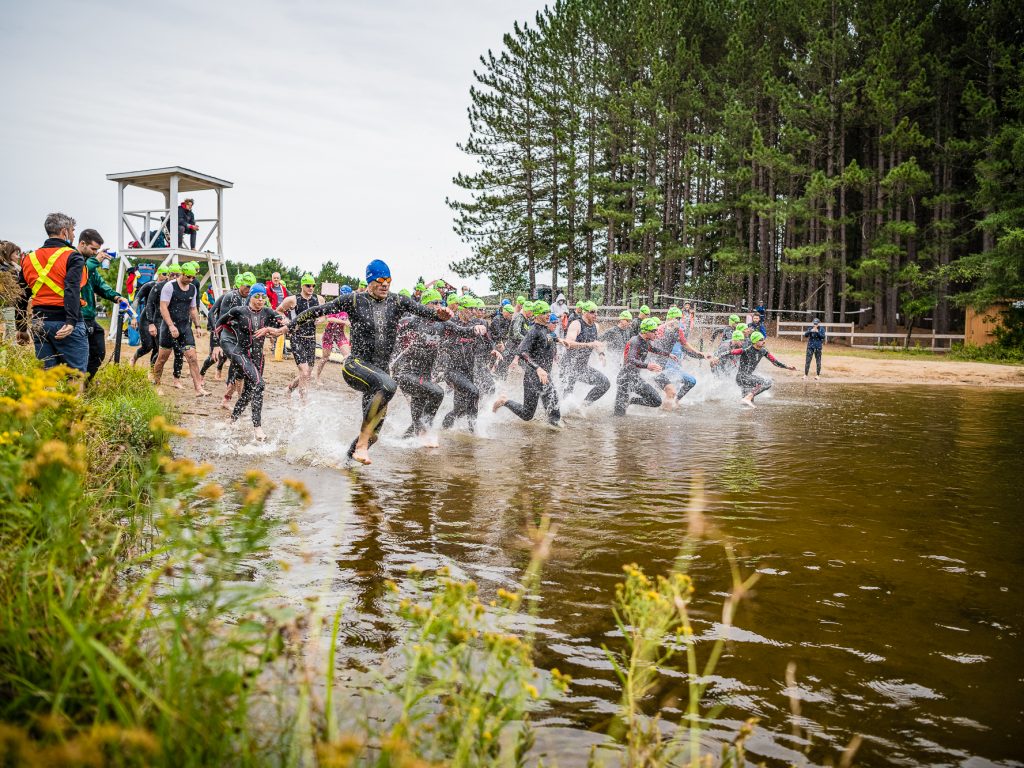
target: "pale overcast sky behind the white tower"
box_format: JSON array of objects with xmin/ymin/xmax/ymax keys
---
[{"xmin": 0, "ymin": 0, "xmax": 543, "ymax": 291}]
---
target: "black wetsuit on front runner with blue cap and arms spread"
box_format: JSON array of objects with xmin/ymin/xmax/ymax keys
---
[{"xmin": 295, "ymin": 293, "xmax": 437, "ymax": 456}]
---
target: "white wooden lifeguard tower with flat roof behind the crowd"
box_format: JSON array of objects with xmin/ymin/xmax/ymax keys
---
[{"xmin": 106, "ymin": 166, "xmax": 234, "ymax": 339}]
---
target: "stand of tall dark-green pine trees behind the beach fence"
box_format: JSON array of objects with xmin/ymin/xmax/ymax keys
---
[{"xmin": 449, "ymin": 0, "xmax": 1024, "ymax": 333}]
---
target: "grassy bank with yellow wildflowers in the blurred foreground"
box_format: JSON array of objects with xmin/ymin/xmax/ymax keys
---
[{"xmin": 0, "ymin": 345, "xmax": 786, "ymax": 766}]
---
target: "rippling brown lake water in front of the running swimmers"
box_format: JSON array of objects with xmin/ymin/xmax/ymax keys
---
[{"xmin": 209, "ymin": 384, "xmax": 1024, "ymax": 765}]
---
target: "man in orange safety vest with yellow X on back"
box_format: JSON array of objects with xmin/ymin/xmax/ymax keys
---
[{"xmin": 15, "ymin": 213, "xmax": 89, "ymax": 373}]
